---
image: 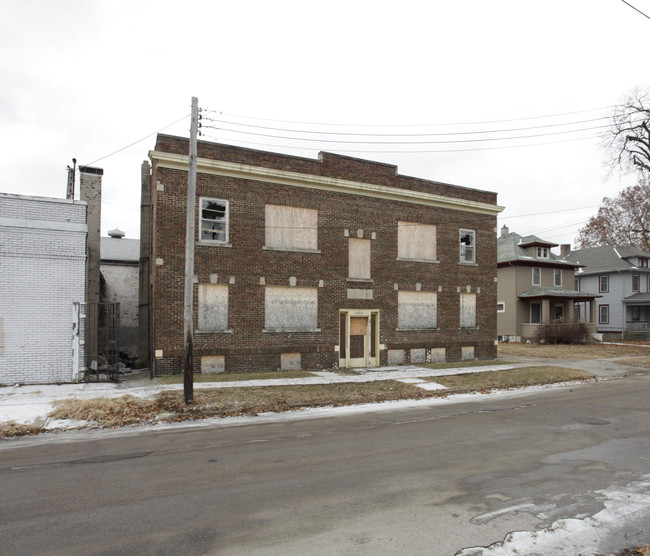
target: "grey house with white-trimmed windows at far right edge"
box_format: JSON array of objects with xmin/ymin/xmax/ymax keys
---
[{"xmin": 567, "ymin": 246, "xmax": 650, "ymax": 338}]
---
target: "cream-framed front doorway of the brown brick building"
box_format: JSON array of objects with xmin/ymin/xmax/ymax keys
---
[{"xmin": 339, "ymin": 309, "xmax": 379, "ymax": 369}]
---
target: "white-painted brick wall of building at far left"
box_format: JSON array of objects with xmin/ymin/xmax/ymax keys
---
[{"xmin": 0, "ymin": 193, "xmax": 86, "ymax": 384}]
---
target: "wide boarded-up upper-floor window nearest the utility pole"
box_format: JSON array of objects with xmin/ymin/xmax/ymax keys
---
[{"xmin": 265, "ymin": 205, "xmax": 318, "ymax": 251}]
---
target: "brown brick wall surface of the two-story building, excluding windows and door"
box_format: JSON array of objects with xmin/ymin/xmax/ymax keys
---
[{"xmin": 151, "ymin": 135, "xmax": 496, "ymax": 374}]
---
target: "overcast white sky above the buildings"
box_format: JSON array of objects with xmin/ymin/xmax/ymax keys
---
[{"xmin": 0, "ymin": 0, "xmax": 650, "ymax": 248}]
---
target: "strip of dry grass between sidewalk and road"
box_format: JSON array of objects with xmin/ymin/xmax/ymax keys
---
[{"xmin": 36, "ymin": 367, "xmax": 591, "ymax": 434}]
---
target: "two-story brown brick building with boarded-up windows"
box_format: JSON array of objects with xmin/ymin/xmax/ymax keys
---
[{"xmin": 141, "ymin": 135, "xmax": 502, "ymax": 374}]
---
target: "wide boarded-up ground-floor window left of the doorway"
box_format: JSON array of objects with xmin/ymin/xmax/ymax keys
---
[{"xmin": 264, "ymin": 286, "xmax": 318, "ymax": 330}]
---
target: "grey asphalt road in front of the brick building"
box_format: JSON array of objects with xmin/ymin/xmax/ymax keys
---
[{"xmin": 0, "ymin": 375, "xmax": 650, "ymax": 556}]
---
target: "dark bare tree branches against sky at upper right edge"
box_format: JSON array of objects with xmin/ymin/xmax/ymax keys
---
[{"xmin": 603, "ymin": 89, "xmax": 650, "ymax": 176}]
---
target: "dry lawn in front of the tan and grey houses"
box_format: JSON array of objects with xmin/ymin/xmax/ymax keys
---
[{"xmin": 498, "ymin": 342, "xmax": 650, "ymax": 360}]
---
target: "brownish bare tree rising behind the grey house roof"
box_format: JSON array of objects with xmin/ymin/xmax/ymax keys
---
[{"xmin": 576, "ymin": 179, "xmax": 650, "ymax": 252}]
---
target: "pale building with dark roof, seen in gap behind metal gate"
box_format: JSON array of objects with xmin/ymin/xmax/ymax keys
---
[{"xmin": 99, "ymin": 229, "xmax": 140, "ymax": 363}]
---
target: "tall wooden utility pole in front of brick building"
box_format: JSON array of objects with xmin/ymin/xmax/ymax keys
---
[{"xmin": 183, "ymin": 97, "xmax": 199, "ymax": 404}]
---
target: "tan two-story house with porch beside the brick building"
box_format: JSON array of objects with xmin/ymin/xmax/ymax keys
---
[{"xmin": 497, "ymin": 226, "xmax": 598, "ymax": 342}]
